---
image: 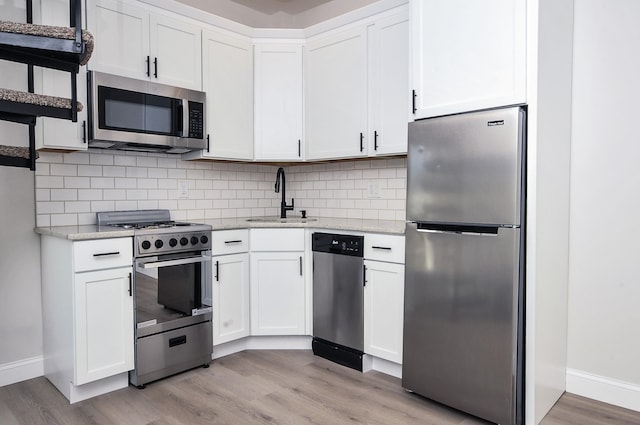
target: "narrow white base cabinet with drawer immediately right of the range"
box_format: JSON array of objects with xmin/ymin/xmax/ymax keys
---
[{"xmin": 211, "ymin": 230, "xmax": 251, "ymax": 346}]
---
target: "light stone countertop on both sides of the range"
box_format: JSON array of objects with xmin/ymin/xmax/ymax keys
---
[{"xmin": 35, "ymin": 217, "xmax": 405, "ymax": 241}]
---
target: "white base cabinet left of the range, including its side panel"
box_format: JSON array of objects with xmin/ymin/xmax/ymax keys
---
[{"xmin": 41, "ymin": 235, "xmax": 134, "ymax": 403}]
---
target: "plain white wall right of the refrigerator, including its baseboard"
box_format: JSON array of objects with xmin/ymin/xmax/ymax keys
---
[{"xmin": 567, "ymin": 0, "xmax": 640, "ymax": 410}]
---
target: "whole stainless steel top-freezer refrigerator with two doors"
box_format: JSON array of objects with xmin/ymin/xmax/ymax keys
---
[{"xmin": 402, "ymin": 107, "xmax": 526, "ymax": 425}]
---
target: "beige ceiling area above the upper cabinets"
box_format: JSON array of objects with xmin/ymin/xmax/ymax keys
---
[{"xmin": 172, "ymin": 0, "xmax": 377, "ymax": 28}]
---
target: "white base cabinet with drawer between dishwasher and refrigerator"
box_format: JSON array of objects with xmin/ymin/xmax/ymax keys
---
[{"xmin": 364, "ymin": 234, "xmax": 404, "ymax": 363}]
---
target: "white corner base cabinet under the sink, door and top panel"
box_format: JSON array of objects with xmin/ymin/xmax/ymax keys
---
[{"xmin": 251, "ymin": 229, "xmax": 306, "ymax": 335}]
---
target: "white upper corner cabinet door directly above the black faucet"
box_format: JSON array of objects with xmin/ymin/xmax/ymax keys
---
[{"xmin": 254, "ymin": 44, "xmax": 302, "ymax": 161}]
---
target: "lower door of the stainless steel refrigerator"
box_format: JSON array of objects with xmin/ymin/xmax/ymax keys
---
[{"xmin": 402, "ymin": 223, "xmax": 520, "ymax": 425}]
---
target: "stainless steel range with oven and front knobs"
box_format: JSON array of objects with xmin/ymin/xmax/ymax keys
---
[{"xmin": 97, "ymin": 210, "xmax": 213, "ymax": 388}]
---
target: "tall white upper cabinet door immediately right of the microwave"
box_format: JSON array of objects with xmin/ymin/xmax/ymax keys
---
[{"xmin": 203, "ymin": 31, "xmax": 253, "ymax": 159}]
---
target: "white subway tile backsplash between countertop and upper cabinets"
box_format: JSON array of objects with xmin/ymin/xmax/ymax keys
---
[{"xmin": 36, "ymin": 150, "xmax": 406, "ymax": 226}]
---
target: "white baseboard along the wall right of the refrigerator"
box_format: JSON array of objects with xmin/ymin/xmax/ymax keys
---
[{"xmin": 567, "ymin": 369, "xmax": 640, "ymax": 412}]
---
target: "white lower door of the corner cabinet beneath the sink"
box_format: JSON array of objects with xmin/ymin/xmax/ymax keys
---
[{"xmin": 251, "ymin": 252, "xmax": 305, "ymax": 335}]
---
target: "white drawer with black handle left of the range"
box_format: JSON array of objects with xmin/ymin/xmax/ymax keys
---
[{"xmin": 73, "ymin": 238, "xmax": 133, "ymax": 272}]
